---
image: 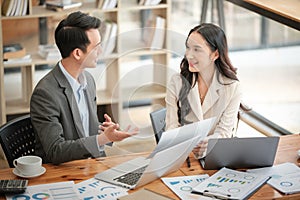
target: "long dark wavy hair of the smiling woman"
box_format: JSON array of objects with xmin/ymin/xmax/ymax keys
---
[{"xmin": 177, "ymin": 23, "xmax": 238, "ymax": 125}]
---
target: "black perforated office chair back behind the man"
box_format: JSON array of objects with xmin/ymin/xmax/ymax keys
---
[{"xmin": 0, "ymin": 114, "xmax": 35, "ymax": 168}]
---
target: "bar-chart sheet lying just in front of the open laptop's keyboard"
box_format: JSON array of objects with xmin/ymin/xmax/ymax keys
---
[{"xmin": 75, "ymin": 178, "xmax": 128, "ymax": 200}]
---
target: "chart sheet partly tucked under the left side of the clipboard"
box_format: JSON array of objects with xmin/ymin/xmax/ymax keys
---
[{"xmin": 161, "ymin": 174, "xmax": 210, "ymax": 200}]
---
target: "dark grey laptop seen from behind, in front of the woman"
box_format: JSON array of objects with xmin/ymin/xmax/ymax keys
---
[{"xmin": 199, "ymin": 137, "xmax": 279, "ymax": 169}]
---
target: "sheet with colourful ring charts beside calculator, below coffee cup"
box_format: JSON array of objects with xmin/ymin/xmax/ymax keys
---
[{"xmin": 6, "ymin": 181, "xmax": 79, "ymax": 200}]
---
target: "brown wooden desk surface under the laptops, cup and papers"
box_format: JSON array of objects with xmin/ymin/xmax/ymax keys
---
[{"xmin": 0, "ymin": 134, "xmax": 300, "ymax": 200}]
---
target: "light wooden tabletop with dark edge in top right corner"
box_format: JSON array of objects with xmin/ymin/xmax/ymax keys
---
[{"xmin": 226, "ymin": 0, "xmax": 300, "ymax": 30}]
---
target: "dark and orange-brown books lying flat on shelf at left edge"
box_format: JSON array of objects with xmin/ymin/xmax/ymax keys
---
[{"xmin": 3, "ymin": 44, "xmax": 26, "ymax": 60}]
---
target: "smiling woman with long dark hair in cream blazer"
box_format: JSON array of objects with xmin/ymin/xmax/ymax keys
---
[{"xmin": 166, "ymin": 23, "xmax": 241, "ymax": 157}]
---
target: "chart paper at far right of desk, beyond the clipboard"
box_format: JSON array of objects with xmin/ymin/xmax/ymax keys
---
[{"xmin": 247, "ymin": 162, "xmax": 300, "ymax": 194}]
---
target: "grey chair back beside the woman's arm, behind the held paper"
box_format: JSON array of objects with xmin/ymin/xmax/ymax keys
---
[{"xmin": 150, "ymin": 108, "xmax": 167, "ymax": 143}]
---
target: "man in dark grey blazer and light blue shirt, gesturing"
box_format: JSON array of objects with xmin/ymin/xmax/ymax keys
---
[{"xmin": 30, "ymin": 11, "xmax": 138, "ymax": 164}]
